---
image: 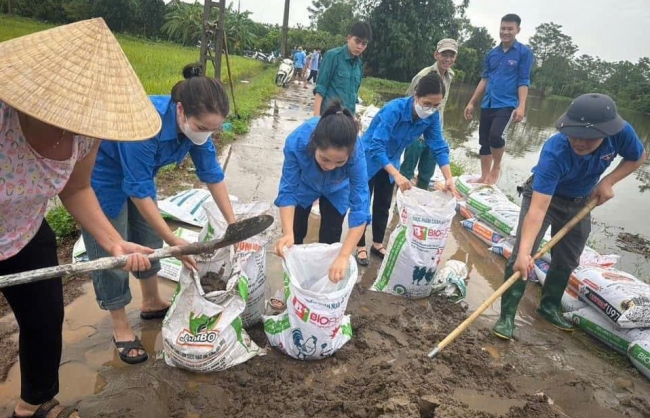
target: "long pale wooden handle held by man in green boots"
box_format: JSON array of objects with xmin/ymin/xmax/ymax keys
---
[{"xmin": 429, "ymin": 199, "xmax": 598, "ymax": 358}]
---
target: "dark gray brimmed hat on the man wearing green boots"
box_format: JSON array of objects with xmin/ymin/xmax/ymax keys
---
[{"xmin": 555, "ymin": 93, "xmax": 626, "ymax": 139}]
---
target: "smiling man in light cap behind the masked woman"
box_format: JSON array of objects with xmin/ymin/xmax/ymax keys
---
[{"xmin": 399, "ymin": 38, "xmax": 458, "ymax": 190}]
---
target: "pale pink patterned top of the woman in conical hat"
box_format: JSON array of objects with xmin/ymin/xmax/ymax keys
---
[{"xmin": 0, "ymin": 101, "xmax": 95, "ymax": 260}]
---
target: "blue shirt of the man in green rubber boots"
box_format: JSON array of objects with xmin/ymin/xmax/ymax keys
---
[{"xmin": 532, "ymin": 123, "xmax": 644, "ymax": 198}]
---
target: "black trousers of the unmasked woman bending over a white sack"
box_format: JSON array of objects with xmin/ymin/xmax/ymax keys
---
[{"xmin": 293, "ymin": 196, "xmax": 345, "ymax": 244}]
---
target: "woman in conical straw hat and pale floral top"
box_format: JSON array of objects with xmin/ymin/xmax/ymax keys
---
[{"xmin": 0, "ymin": 19, "xmax": 161, "ymax": 418}]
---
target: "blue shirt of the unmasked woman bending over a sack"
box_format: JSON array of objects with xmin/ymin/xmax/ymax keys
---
[{"xmin": 275, "ymin": 116, "xmax": 370, "ymax": 228}]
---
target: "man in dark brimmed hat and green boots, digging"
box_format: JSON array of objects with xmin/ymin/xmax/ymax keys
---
[{"xmin": 492, "ymin": 93, "xmax": 646, "ymax": 339}]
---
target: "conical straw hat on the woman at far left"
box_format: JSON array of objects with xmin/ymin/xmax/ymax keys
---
[{"xmin": 0, "ymin": 18, "xmax": 162, "ymax": 141}]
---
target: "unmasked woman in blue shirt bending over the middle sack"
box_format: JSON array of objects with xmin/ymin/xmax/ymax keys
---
[{"xmin": 275, "ymin": 102, "xmax": 370, "ymax": 282}]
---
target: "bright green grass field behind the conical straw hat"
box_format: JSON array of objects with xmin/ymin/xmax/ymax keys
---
[{"xmin": 0, "ymin": 15, "xmax": 278, "ymax": 134}]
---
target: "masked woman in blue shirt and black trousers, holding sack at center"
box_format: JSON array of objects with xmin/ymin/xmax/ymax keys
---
[{"xmin": 356, "ymin": 72, "xmax": 456, "ymax": 266}]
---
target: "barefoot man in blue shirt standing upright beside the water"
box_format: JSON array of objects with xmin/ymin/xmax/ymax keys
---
[{"xmin": 464, "ymin": 14, "xmax": 535, "ymax": 184}]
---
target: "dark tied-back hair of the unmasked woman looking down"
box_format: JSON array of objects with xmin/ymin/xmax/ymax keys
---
[{"xmin": 309, "ymin": 101, "xmax": 359, "ymax": 155}]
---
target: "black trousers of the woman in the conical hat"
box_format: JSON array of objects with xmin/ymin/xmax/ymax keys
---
[{"xmin": 0, "ymin": 220, "xmax": 63, "ymax": 405}]
